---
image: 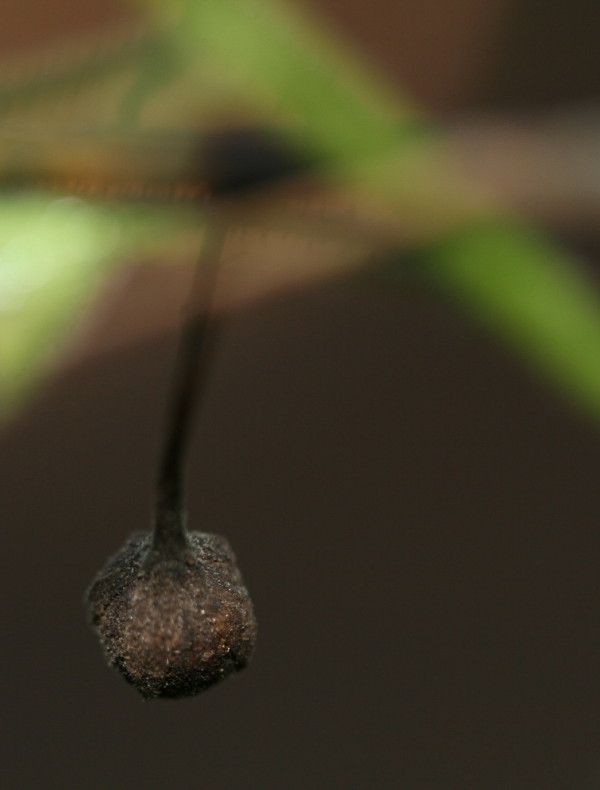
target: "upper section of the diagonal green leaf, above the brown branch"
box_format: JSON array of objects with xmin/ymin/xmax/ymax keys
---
[{"xmin": 142, "ymin": 0, "xmax": 417, "ymax": 167}]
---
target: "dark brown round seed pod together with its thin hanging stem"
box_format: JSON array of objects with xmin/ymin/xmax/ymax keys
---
[{"xmin": 87, "ymin": 228, "xmax": 256, "ymax": 698}]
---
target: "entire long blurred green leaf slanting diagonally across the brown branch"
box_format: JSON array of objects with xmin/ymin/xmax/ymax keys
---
[{"xmin": 159, "ymin": 0, "xmax": 600, "ymax": 417}]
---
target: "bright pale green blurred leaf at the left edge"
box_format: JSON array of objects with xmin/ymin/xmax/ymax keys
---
[{"xmin": 0, "ymin": 195, "xmax": 202, "ymax": 416}]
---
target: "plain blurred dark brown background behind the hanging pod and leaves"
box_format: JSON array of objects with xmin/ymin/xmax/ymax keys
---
[{"xmin": 0, "ymin": 0, "xmax": 600, "ymax": 790}]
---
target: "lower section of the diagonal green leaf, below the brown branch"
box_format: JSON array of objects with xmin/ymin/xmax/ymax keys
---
[{"xmin": 423, "ymin": 219, "xmax": 600, "ymax": 418}]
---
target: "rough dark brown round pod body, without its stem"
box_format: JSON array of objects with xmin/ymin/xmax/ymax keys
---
[{"xmin": 87, "ymin": 532, "xmax": 256, "ymax": 698}]
